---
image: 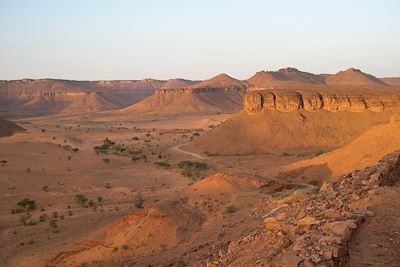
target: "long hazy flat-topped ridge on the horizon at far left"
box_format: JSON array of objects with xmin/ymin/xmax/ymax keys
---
[{"xmin": 0, "ymin": 79, "xmax": 165, "ymax": 115}]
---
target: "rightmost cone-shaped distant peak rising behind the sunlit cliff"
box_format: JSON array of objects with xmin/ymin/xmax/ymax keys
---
[{"xmin": 325, "ymin": 68, "xmax": 386, "ymax": 86}]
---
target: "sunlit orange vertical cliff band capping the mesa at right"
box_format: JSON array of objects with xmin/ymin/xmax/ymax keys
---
[{"xmin": 244, "ymin": 90, "xmax": 400, "ymax": 113}]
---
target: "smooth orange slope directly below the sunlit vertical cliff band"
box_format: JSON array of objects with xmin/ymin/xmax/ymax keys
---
[{"xmin": 188, "ymin": 110, "xmax": 391, "ymax": 154}]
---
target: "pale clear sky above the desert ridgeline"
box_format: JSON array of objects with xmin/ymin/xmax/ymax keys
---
[{"xmin": 0, "ymin": 0, "xmax": 400, "ymax": 80}]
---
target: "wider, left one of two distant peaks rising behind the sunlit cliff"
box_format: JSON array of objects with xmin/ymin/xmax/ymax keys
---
[{"xmin": 247, "ymin": 68, "xmax": 324, "ymax": 87}]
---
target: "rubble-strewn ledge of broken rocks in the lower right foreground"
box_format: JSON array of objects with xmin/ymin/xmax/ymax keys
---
[{"xmin": 202, "ymin": 151, "xmax": 400, "ymax": 266}]
